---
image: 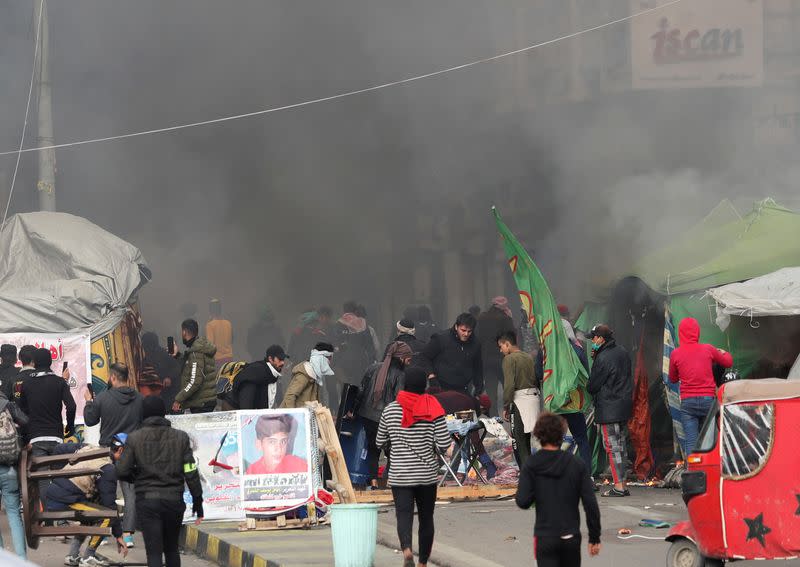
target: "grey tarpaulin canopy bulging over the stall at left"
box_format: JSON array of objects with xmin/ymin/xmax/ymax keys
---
[{"xmin": 0, "ymin": 212, "xmax": 150, "ymax": 337}]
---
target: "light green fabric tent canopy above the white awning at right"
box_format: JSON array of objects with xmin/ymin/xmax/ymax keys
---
[{"xmin": 631, "ymin": 199, "xmax": 800, "ymax": 295}]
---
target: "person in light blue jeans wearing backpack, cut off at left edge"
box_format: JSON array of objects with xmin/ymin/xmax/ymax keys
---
[{"xmin": 0, "ymin": 393, "xmax": 28, "ymax": 559}]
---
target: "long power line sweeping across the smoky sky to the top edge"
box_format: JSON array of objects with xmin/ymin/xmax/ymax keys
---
[{"xmin": 0, "ymin": 0, "xmax": 683, "ymax": 156}]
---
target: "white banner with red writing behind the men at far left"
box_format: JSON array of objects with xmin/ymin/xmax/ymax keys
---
[{"xmin": 0, "ymin": 333, "xmax": 91, "ymax": 423}]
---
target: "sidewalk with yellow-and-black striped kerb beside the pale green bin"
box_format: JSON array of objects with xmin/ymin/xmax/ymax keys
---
[{"xmin": 181, "ymin": 514, "xmax": 418, "ymax": 567}]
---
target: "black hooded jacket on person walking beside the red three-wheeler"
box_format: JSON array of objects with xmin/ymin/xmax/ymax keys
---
[{"xmin": 516, "ymin": 449, "xmax": 600, "ymax": 543}]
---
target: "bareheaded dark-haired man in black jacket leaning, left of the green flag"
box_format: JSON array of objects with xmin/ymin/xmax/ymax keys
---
[{"xmin": 420, "ymin": 313, "xmax": 483, "ymax": 396}]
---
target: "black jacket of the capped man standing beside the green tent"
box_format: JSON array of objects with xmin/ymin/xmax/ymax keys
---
[{"xmin": 586, "ymin": 339, "xmax": 633, "ymax": 423}]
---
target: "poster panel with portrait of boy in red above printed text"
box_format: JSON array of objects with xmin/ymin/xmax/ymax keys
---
[{"xmin": 239, "ymin": 409, "xmax": 314, "ymax": 510}]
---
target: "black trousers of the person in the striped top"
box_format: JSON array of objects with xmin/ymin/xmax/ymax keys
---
[{"xmin": 392, "ymin": 484, "xmax": 436, "ymax": 564}]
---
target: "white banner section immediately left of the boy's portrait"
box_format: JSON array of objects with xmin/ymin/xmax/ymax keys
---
[{"xmin": 168, "ymin": 411, "xmax": 244, "ymax": 522}]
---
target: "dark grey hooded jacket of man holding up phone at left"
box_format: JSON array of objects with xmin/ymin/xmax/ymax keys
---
[{"xmin": 83, "ymin": 386, "xmax": 144, "ymax": 447}]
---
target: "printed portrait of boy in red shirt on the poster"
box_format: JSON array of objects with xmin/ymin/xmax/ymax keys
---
[{"xmin": 245, "ymin": 415, "xmax": 308, "ymax": 474}]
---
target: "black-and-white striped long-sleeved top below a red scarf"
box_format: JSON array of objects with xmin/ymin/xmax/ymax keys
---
[{"xmin": 375, "ymin": 402, "xmax": 451, "ymax": 486}]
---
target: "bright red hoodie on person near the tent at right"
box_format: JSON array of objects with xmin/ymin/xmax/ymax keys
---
[{"xmin": 669, "ymin": 317, "xmax": 733, "ymax": 400}]
